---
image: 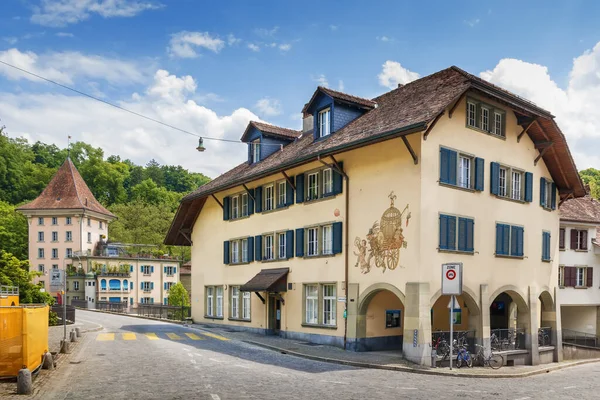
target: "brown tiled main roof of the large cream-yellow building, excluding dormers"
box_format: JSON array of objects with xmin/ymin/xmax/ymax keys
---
[{"xmin": 165, "ymin": 67, "xmax": 585, "ymax": 245}]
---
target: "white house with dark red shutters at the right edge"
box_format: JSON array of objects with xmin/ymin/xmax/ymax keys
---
[{"xmin": 558, "ymin": 192, "xmax": 600, "ymax": 338}]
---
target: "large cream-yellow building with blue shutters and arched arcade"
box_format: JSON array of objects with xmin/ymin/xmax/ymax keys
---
[{"xmin": 165, "ymin": 67, "xmax": 585, "ymax": 364}]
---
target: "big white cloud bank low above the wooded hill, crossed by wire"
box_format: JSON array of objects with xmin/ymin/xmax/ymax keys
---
[{"xmin": 0, "ymin": 70, "xmax": 258, "ymax": 177}]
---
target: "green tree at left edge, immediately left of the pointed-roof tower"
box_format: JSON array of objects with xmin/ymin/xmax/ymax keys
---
[{"xmin": 0, "ymin": 201, "xmax": 28, "ymax": 260}]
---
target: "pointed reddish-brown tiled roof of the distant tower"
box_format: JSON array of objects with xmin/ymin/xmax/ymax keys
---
[{"xmin": 17, "ymin": 158, "xmax": 116, "ymax": 218}]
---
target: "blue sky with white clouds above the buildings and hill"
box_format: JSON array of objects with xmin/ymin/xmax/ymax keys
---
[{"xmin": 0, "ymin": 0, "xmax": 600, "ymax": 177}]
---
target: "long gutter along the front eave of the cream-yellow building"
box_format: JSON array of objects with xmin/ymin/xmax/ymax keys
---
[{"xmin": 181, "ymin": 122, "xmax": 427, "ymax": 203}]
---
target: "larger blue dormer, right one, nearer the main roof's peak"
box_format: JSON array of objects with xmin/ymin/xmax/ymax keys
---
[{"xmin": 302, "ymin": 86, "xmax": 377, "ymax": 140}]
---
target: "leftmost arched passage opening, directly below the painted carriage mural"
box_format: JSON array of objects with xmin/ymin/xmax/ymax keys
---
[{"xmin": 355, "ymin": 283, "xmax": 404, "ymax": 351}]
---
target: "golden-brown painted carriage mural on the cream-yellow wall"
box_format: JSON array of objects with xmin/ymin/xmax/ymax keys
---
[{"xmin": 354, "ymin": 192, "xmax": 411, "ymax": 274}]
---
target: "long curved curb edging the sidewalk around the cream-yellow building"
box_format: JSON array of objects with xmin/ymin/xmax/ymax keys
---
[{"xmin": 242, "ymin": 340, "xmax": 600, "ymax": 379}]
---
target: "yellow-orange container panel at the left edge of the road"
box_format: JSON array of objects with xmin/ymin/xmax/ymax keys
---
[{"xmin": 0, "ymin": 306, "xmax": 49, "ymax": 377}]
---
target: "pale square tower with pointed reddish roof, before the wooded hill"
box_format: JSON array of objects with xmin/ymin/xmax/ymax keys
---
[{"xmin": 17, "ymin": 158, "xmax": 116, "ymax": 297}]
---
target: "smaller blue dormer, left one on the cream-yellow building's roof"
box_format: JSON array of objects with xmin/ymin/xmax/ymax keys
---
[{"xmin": 241, "ymin": 121, "xmax": 301, "ymax": 164}]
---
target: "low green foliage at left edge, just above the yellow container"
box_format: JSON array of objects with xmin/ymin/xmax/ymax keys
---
[{"xmin": 0, "ymin": 250, "xmax": 54, "ymax": 304}]
